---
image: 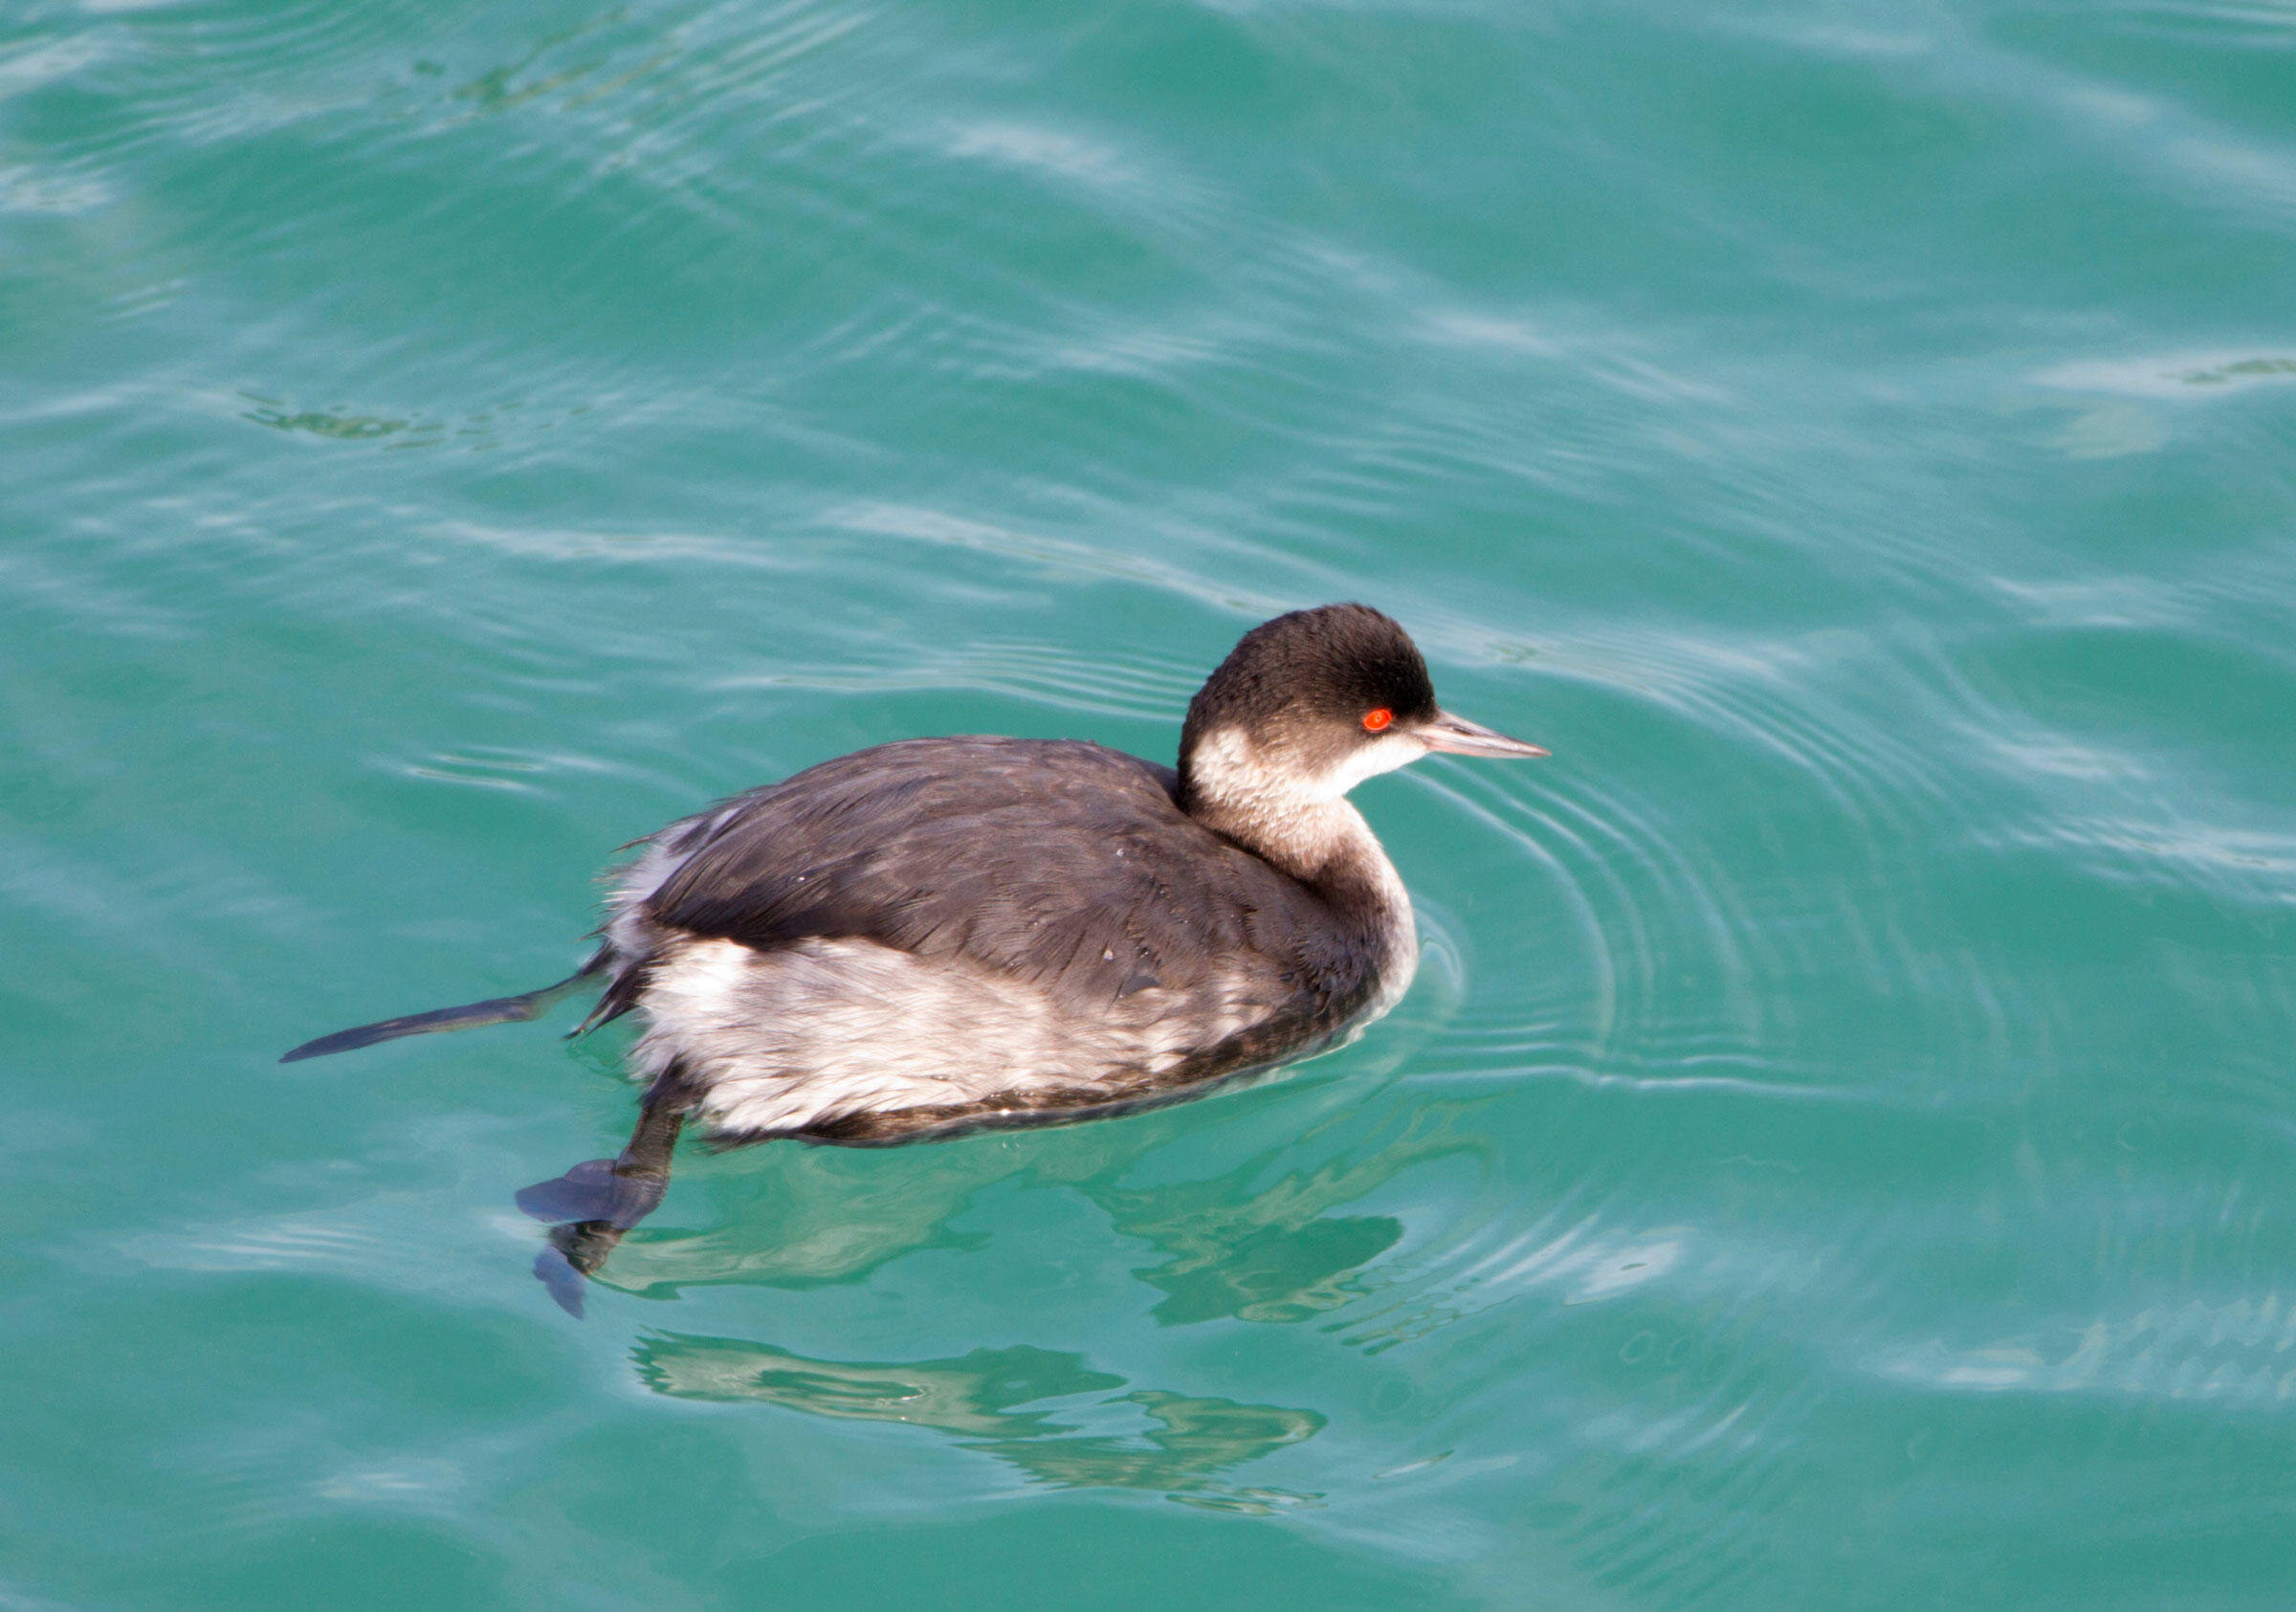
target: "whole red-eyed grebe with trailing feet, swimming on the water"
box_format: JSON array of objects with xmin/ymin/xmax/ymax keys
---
[{"xmin": 287, "ymin": 604, "xmax": 1545, "ymax": 1309}]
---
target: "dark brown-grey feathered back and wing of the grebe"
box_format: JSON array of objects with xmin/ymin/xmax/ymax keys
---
[{"xmin": 643, "ymin": 737, "xmax": 1340, "ymax": 1008}]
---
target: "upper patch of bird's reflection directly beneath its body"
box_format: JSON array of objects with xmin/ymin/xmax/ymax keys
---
[{"xmin": 597, "ymin": 1102, "xmax": 1474, "ymax": 1325}]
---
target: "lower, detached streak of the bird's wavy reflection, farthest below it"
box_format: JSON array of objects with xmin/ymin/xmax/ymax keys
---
[{"xmin": 636, "ymin": 1332, "xmax": 1322, "ymax": 1513}]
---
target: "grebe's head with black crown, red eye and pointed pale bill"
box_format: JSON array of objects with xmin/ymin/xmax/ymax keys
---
[{"xmin": 1181, "ymin": 604, "xmax": 1545, "ymax": 829}]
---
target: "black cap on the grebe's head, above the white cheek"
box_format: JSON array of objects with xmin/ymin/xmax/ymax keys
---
[{"xmin": 1181, "ymin": 604, "xmax": 1435, "ymax": 758}]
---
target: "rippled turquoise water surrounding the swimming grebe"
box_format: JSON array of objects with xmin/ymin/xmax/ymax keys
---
[{"xmin": 0, "ymin": 0, "xmax": 2296, "ymax": 1612}]
